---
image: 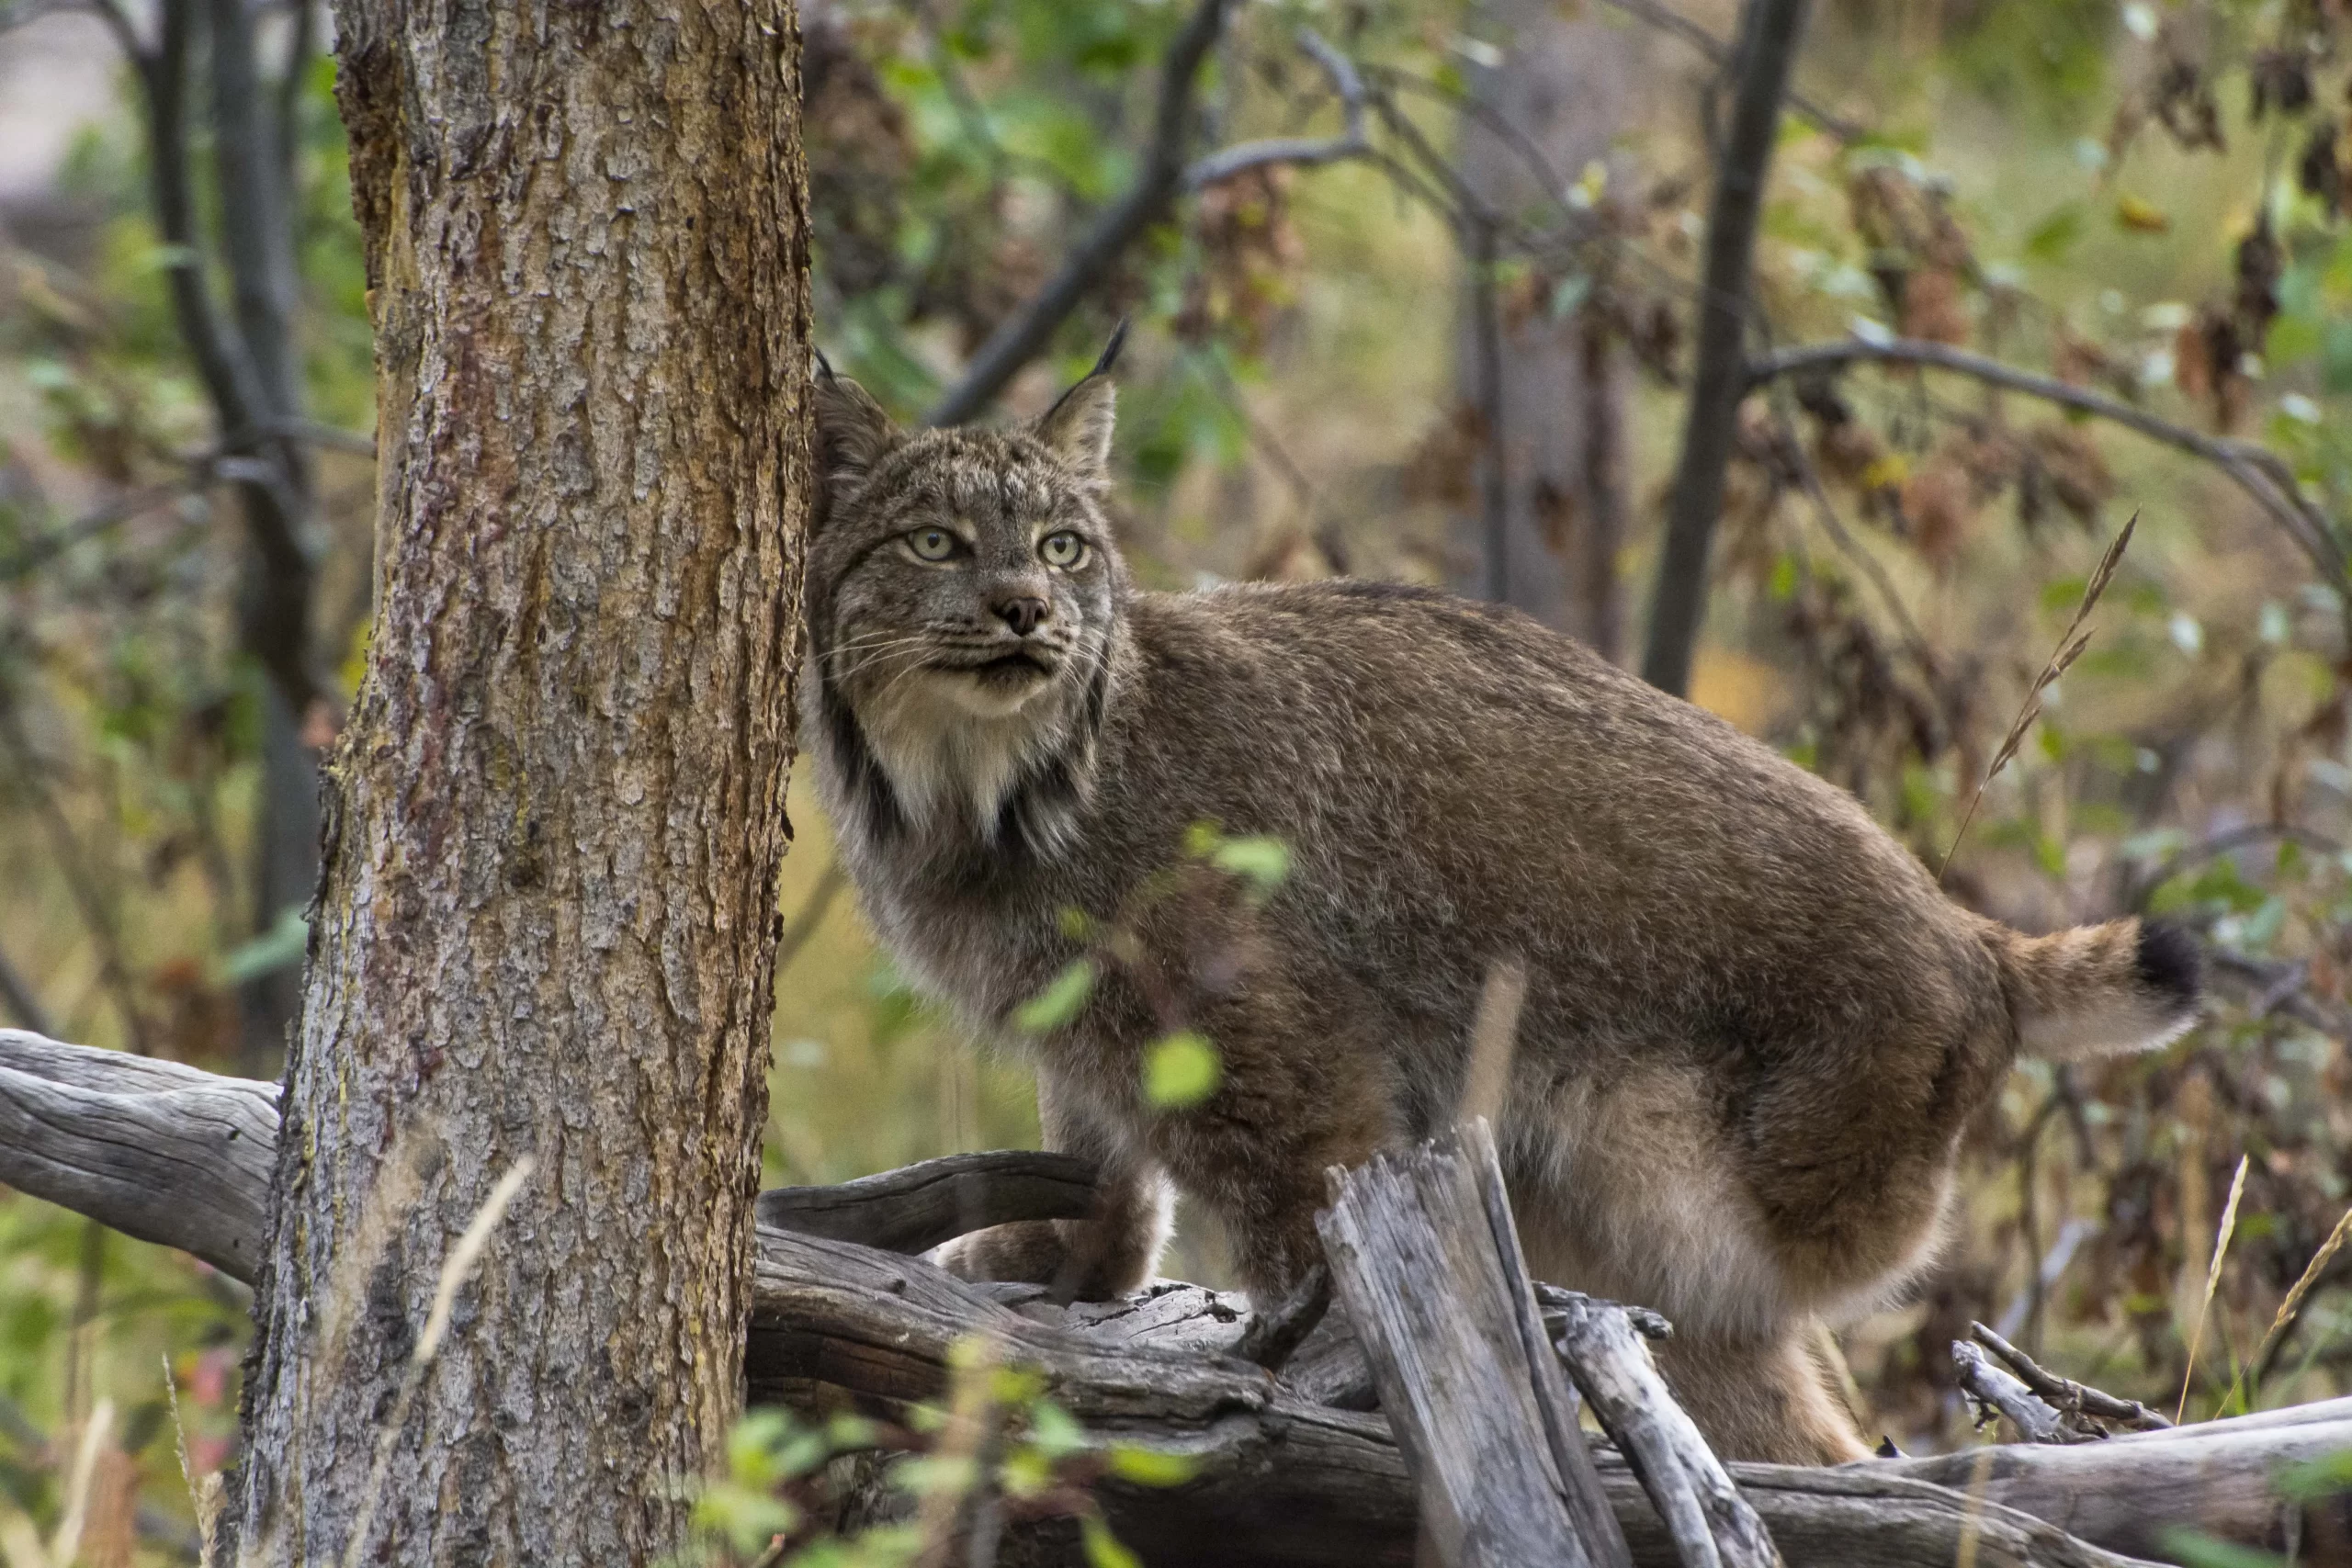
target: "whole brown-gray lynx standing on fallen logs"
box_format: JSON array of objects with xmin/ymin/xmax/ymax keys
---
[{"xmin": 802, "ymin": 338, "xmax": 2199, "ymax": 1462}]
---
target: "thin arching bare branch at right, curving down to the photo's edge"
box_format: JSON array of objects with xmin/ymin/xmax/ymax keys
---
[{"xmin": 1747, "ymin": 339, "xmax": 2352, "ymax": 597}]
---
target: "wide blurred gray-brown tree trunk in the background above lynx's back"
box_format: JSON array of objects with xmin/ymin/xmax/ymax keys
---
[{"xmin": 1456, "ymin": 0, "xmax": 1644, "ymax": 659}]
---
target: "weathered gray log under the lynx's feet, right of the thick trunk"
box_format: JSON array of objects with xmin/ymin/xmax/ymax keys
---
[{"xmin": 748, "ymin": 1229, "xmax": 2164, "ymax": 1568}]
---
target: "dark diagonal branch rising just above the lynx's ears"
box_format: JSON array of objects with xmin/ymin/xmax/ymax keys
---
[{"xmin": 924, "ymin": 0, "xmax": 1232, "ymax": 425}]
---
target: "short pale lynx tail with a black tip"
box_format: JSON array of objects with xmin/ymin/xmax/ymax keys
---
[{"xmin": 1990, "ymin": 919, "xmax": 2201, "ymax": 1063}]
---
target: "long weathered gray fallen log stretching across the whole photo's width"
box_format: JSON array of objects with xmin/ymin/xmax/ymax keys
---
[{"xmin": 0, "ymin": 1030, "xmax": 2352, "ymax": 1568}]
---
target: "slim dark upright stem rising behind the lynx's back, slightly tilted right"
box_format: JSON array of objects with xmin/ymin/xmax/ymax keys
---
[{"xmin": 1642, "ymin": 0, "xmax": 1804, "ymax": 696}]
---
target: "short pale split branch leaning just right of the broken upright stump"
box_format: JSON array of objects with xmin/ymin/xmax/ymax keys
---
[{"xmin": 1547, "ymin": 1291, "xmax": 1781, "ymax": 1568}]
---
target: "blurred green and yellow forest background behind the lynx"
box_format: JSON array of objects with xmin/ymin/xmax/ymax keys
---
[{"xmin": 0, "ymin": 0, "xmax": 2352, "ymax": 1561}]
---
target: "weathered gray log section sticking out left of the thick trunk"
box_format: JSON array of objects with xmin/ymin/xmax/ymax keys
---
[{"xmin": 0, "ymin": 1030, "xmax": 277, "ymax": 1281}]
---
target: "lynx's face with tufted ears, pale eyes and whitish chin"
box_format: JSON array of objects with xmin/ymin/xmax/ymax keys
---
[{"xmin": 809, "ymin": 364, "xmax": 1126, "ymax": 840}]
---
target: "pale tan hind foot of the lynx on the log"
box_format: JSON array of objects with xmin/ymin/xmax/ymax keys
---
[{"xmin": 1658, "ymin": 1319, "xmax": 1870, "ymax": 1464}]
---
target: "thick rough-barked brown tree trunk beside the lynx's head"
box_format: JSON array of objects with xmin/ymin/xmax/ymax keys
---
[{"xmin": 229, "ymin": 0, "xmax": 809, "ymax": 1565}]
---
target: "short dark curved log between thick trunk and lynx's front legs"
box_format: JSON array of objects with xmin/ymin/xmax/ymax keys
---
[{"xmin": 757, "ymin": 1149, "xmax": 1093, "ymax": 1253}]
